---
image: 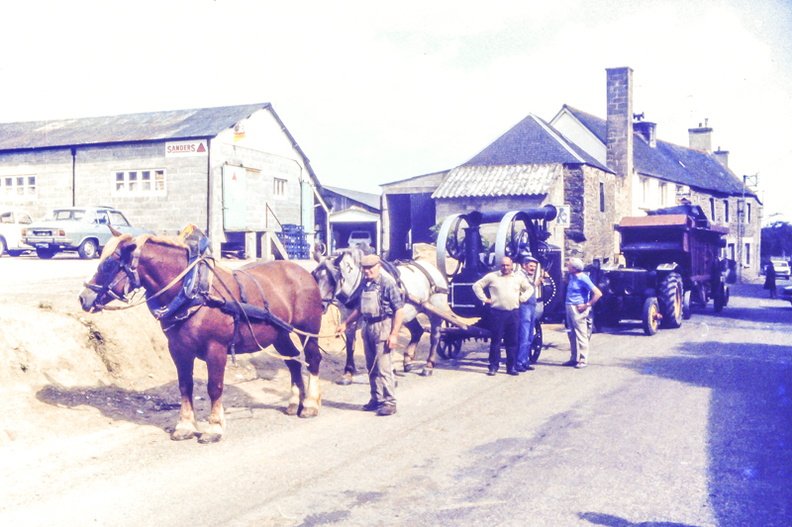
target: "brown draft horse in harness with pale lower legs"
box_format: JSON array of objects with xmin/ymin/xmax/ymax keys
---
[{"xmin": 80, "ymin": 233, "xmax": 322, "ymax": 443}]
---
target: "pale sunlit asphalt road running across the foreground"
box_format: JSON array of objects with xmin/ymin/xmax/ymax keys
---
[{"xmin": 0, "ymin": 258, "xmax": 792, "ymax": 527}]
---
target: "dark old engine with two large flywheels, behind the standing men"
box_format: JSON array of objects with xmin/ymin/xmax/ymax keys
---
[{"xmin": 437, "ymin": 205, "xmax": 564, "ymax": 362}]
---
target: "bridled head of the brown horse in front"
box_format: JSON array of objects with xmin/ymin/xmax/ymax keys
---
[{"xmin": 80, "ymin": 231, "xmax": 141, "ymax": 313}]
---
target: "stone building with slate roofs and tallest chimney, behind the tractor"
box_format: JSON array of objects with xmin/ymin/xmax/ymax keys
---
[{"xmin": 382, "ymin": 68, "xmax": 761, "ymax": 277}]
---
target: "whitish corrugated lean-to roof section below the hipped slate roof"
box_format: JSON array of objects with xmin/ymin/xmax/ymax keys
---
[{"xmin": 432, "ymin": 163, "xmax": 563, "ymax": 198}]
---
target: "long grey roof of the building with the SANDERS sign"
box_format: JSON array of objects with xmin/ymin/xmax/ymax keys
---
[{"xmin": 0, "ymin": 103, "xmax": 271, "ymax": 151}]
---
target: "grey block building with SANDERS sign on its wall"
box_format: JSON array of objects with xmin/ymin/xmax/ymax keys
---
[{"xmin": 0, "ymin": 103, "xmax": 328, "ymax": 257}]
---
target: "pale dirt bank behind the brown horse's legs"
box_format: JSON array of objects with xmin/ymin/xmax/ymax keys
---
[{"xmin": 0, "ymin": 299, "xmax": 352, "ymax": 445}]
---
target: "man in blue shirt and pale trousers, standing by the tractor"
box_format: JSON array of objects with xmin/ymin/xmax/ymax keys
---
[{"xmin": 564, "ymin": 258, "xmax": 602, "ymax": 368}]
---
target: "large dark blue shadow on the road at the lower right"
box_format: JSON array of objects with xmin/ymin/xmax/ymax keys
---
[{"xmin": 628, "ymin": 340, "xmax": 792, "ymax": 527}]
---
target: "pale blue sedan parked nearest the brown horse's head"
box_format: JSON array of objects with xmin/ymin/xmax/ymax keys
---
[{"xmin": 22, "ymin": 207, "xmax": 154, "ymax": 259}]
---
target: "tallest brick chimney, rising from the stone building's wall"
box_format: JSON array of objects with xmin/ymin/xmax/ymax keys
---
[{"xmin": 605, "ymin": 68, "xmax": 633, "ymax": 178}]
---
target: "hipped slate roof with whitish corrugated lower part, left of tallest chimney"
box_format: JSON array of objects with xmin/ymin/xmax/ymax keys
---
[{"xmin": 432, "ymin": 114, "xmax": 612, "ymax": 198}]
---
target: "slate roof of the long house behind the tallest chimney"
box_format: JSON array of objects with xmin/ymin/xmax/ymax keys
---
[{"xmin": 564, "ymin": 105, "xmax": 754, "ymax": 196}]
